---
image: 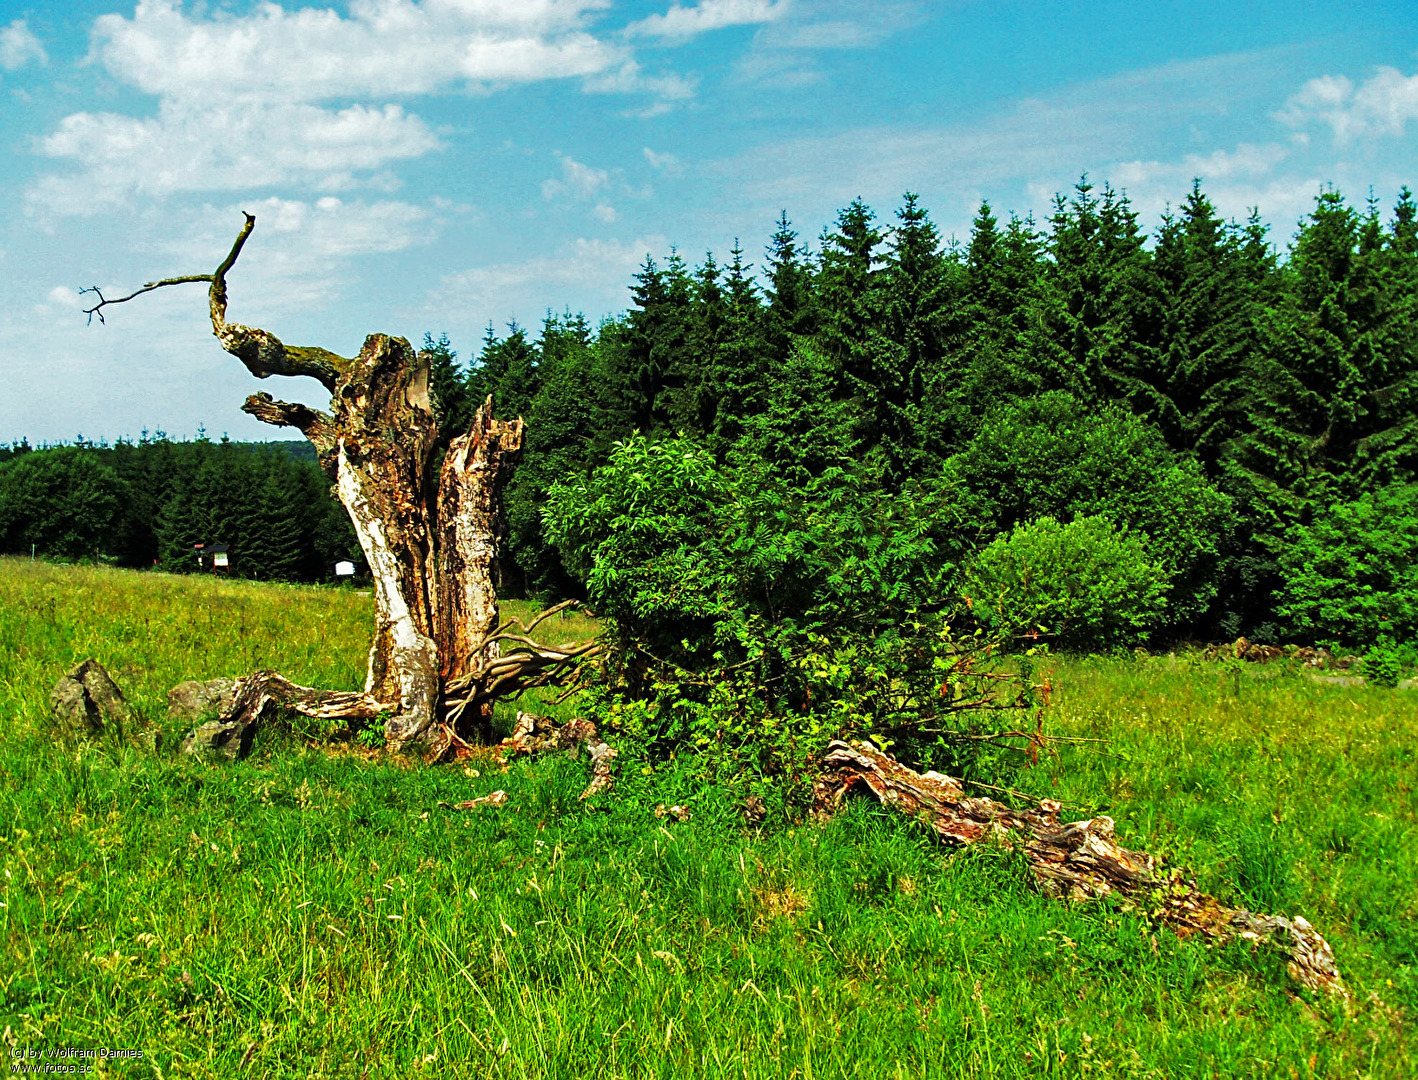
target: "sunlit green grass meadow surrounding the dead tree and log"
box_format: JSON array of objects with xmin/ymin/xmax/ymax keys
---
[{"xmin": 0, "ymin": 560, "xmax": 1418, "ymax": 1080}]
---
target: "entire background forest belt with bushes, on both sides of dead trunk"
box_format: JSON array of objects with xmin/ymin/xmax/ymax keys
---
[{"xmin": 0, "ymin": 179, "xmax": 1418, "ymax": 651}]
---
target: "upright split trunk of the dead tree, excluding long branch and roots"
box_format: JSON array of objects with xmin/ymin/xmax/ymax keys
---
[{"xmin": 244, "ymin": 334, "xmax": 522, "ymax": 750}]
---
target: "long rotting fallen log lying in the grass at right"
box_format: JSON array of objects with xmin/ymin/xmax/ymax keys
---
[{"xmin": 814, "ymin": 741, "xmax": 1346, "ymax": 994}]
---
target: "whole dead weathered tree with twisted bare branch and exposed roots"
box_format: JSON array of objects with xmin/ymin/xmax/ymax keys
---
[{"xmin": 89, "ymin": 214, "xmax": 594, "ymax": 755}]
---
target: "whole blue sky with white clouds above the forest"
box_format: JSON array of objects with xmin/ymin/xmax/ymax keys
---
[{"xmin": 0, "ymin": 0, "xmax": 1418, "ymax": 442}]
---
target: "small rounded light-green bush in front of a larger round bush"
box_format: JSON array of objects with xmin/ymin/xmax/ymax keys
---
[{"xmin": 966, "ymin": 517, "xmax": 1167, "ymax": 651}]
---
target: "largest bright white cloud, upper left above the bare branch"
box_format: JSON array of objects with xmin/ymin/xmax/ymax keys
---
[{"xmin": 31, "ymin": 0, "xmax": 693, "ymax": 215}]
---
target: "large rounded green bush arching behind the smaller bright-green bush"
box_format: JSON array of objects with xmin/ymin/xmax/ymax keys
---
[{"xmin": 940, "ymin": 391, "xmax": 1235, "ymax": 629}]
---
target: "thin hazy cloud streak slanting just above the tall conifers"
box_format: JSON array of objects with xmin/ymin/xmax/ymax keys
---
[{"xmin": 720, "ymin": 54, "xmax": 1312, "ymax": 224}]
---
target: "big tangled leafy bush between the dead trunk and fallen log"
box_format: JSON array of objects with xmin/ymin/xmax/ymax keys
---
[{"xmin": 546, "ymin": 437, "xmax": 1028, "ymax": 785}]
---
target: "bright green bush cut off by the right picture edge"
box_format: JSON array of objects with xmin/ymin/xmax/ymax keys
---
[{"xmin": 1279, "ymin": 483, "xmax": 1418, "ymax": 645}]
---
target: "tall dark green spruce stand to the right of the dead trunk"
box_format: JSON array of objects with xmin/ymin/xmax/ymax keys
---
[{"xmin": 445, "ymin": 180, "xmax": 1418, "ymax": 639}]
